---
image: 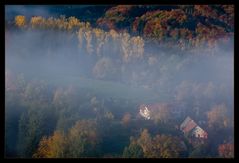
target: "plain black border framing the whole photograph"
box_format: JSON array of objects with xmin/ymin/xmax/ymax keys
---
[{"xmin": 0, "ymin": 0, "xmax": 239, "ymax": 161}]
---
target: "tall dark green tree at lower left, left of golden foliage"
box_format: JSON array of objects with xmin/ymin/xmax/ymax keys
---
[{"xmin": 17, "ymin": 106, "xmax": 56, "ymax": 157}]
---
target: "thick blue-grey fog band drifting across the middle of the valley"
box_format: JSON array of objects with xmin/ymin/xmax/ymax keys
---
[{"xmin": 5, "ymin": 26, "xmax": 234, "ymax": 112}]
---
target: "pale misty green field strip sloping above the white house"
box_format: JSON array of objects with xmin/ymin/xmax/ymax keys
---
[{"xmin": 45, "ymin": 76, "xmax": 168, "ymax": 103}]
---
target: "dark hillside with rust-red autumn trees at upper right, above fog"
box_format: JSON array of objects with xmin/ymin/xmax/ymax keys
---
[{"xmin": 97, "ymin": 5, "xmax": 234, "ymax": 46}]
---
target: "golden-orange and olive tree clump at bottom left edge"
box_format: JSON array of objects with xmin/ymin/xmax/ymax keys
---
[{"xmin": 33, "ymin": 120, "xmax": 99, "ymax": 158}]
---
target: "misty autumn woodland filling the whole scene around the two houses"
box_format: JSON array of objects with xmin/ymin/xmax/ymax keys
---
[{"xmin": 5, "ymin": 5, "xmax": 234, "ymax": 158}]
